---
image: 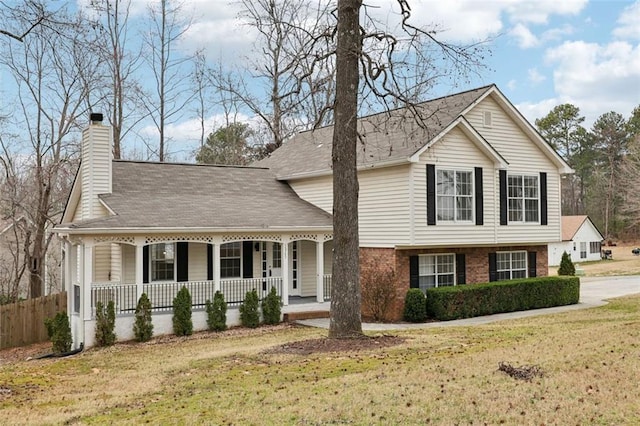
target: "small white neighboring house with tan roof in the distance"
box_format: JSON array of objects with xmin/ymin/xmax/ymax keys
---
[{"xmin": 549, "ymin": 215, "xmax": 604, "ymax": 266}]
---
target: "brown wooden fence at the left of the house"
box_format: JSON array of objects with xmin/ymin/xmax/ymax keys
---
[{"xmin": 0, "ymin": 292, "xmax": 67, "ymax": 349}]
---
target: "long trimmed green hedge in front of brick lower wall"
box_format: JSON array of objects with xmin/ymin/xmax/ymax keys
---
[{"xmin": 427, "ymin": 277, "xmax": 580, "ymax": 321}]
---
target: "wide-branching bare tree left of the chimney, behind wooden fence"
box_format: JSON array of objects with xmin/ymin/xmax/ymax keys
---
[{"xmin": 0, "ymin": 1, "xmax": 98, "ymax": 297}]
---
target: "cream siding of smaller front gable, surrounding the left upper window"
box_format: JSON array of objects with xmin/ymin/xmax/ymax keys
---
[{"xmin": 412, "ymin": 129, "xmax": 498, "ymax": 246}]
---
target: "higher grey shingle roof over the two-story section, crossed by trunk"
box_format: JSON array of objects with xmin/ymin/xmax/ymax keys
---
[{"xmin": 256, "ymin": 85, "xmax": 494, "ymax": 179}]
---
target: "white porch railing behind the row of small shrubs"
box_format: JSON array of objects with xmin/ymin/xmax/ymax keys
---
[{"xmin": 91, "ymin": 277, "xmax": 282, "ymax": 316}]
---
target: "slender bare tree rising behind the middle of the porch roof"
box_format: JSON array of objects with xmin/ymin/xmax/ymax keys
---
[{"xmin": 144, "ymin": 0, "xmax": 194, "ymax": 161}]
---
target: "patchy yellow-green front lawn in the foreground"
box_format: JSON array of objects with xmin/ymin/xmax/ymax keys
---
[{"xmin": 0, "ymin": 297, "xmax": 640, "ymax": 425}]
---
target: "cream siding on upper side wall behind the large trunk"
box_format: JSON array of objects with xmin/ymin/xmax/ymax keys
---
[{"xmin": 290, "ymin": 164, "xmax": 409, "ymax": 247}]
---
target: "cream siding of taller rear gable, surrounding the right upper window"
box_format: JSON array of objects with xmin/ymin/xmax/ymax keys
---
[{"xmin": 465, "ymin": 97, "xmax": 561, "ymax": 244}]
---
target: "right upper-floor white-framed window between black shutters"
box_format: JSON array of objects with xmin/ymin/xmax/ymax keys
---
[{"xmin": 507, "ymin": 175, "xmax": 540, "ymax": 222}]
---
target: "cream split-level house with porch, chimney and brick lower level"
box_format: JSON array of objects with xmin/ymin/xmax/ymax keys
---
[{"xmin": 56, "ymin": 85, "xmax": 572, "ymax": 346}]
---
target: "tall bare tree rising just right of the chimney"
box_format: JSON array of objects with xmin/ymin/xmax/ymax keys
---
[{"xmin": 91, "ymin": 0, "xmax": 147, "ymax": 159}]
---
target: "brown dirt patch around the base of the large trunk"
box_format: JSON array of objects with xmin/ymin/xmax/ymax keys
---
[{"xmin": 265, "ymin": 334, "xmax": 405, "ymax": 355}]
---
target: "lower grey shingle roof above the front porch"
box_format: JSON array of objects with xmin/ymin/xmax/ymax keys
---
[{"xmin": 65, "ymin": 160, "xmax": 332, "ymax": 231}]
